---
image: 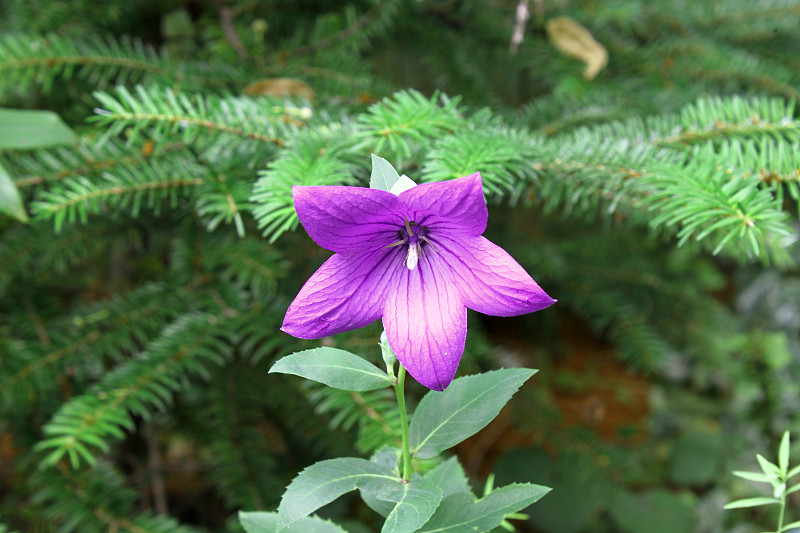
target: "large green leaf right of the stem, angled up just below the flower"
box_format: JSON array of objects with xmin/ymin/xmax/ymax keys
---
[{"xmin": 408, "ymin": 368, "xmax": 536, "ymax": 459}]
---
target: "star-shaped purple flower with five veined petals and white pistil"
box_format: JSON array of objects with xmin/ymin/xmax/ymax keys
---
[{"xmin": 281, "ymin": 173, "xmax": 555, "ymax": 390}]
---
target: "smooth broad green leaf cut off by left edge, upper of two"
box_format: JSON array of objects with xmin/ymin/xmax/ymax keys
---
[{"xmin": 0, "ymin": 108, "xmax": 78, "ymax": 150}]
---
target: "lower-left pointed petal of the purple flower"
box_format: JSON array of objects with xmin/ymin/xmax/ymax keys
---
[{"xmin": 281, "ymin": 248, "xmax": 407, "ymax": 339}]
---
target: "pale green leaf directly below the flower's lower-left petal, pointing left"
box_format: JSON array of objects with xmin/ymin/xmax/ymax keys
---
[{"xmin": 269, "ymin": 347, "xmax": 392, "ymax": 391}]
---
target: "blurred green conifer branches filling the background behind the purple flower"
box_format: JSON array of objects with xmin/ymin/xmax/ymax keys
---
[{"xmin": 0, "ymin": 0, "xmax": 800, "ymax": 533}]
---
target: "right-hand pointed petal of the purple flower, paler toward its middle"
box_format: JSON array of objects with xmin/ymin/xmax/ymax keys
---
[{"xmin": 434, "ymin": 234, "xmax": 556, "ymax": 316}]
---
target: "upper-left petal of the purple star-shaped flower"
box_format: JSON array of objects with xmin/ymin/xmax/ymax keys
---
[{"xmin": 292, "ymin": 185, "xmax": 404, "ymax": 252}]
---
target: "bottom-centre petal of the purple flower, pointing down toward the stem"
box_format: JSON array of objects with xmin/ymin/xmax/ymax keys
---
[{"xmin": 383, "ymin": 254, "xmax": 467, "ymax": 391}]
